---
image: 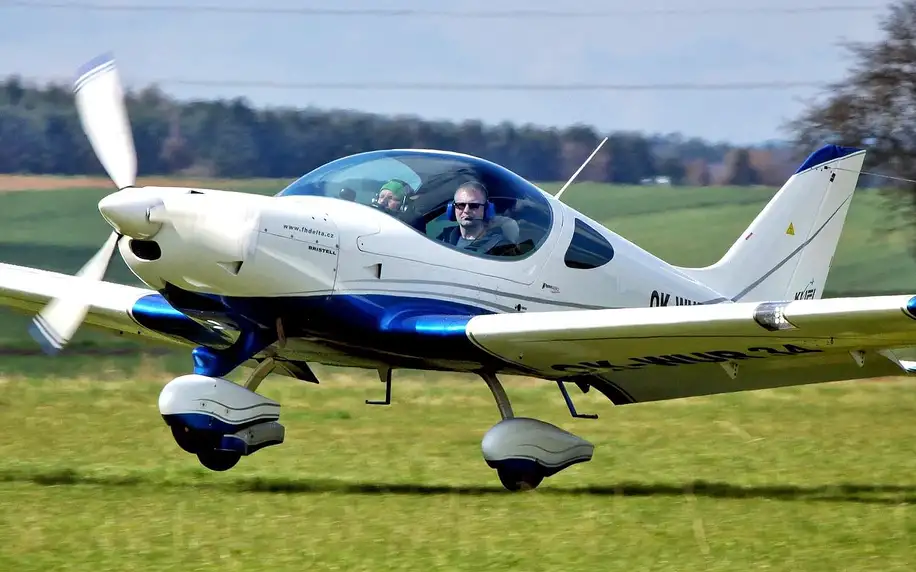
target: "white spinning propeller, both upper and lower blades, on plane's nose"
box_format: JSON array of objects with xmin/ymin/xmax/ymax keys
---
[{"xmin": 29, "ymin": 55, "xmax": 137, "ymax": 353}]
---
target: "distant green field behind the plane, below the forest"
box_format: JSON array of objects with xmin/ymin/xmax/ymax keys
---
[{"xmin": 0, "ymin": 173, "xmax": 916, "ymax": 354}]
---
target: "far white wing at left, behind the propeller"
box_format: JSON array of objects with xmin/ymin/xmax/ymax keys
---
[{"xmin": 0, "ymin": 263, "xmax": 187, "ymax": 347}]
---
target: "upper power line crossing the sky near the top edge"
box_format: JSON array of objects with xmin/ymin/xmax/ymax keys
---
[{"xmin": 0, "ymin": 0, "xmax": 884, "ymax": 19}]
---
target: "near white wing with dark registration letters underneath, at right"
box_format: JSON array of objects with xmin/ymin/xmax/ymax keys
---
[{"xmin": 466, "ymin": 295, "xmax": 916, "ymax": 403}]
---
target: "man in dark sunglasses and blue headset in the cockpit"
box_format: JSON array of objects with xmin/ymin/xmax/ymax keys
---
[{"xmin": 438, "ymin": 181, "xmax": 517, "ymax": 254}]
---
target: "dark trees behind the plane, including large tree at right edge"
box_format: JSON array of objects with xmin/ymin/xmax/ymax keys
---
[{"xmin": 0, "ymin": 0, "xmax": 916, "ymax": 197}]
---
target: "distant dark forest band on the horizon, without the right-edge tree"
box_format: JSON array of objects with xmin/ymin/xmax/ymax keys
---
[{"xmin": 0, "ymin": 76, "xmax": 798, "ymax": 185}]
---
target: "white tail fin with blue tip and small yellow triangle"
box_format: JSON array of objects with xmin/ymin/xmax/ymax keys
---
[{"xmin": 680, "ymin": 145, "xmax": 865, "ymax": 302}]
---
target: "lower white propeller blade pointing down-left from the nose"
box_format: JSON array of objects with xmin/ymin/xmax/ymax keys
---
[{"xmin": 29, "ymin": 232, "xmax": 121, "ymax": 354}]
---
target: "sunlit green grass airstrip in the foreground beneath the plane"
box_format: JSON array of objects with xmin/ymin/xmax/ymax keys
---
[{"xmin": 0, "ymin": 362, "xmax": 916, "ymax": 572}]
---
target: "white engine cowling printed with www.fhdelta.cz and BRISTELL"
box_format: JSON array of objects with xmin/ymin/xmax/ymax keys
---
[{"xmin": 119, "ymin": 190, "xmax": 340, "ymax": 297}]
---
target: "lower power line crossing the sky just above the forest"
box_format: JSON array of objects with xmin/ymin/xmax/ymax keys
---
[{"xmin": 16, "ymin": 77, "xmax": 830, "ymax": 92}]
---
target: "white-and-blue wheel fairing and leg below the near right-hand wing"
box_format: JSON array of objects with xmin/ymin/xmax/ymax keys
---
[{"xmin": 480, "ymin": 372, "xmax": 594, "ymax": 491}]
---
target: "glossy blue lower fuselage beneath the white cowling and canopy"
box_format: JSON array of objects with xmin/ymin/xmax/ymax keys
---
[{"xmin": 132, "ymin": 292, "xmax": 497, "ymax": 367}]
